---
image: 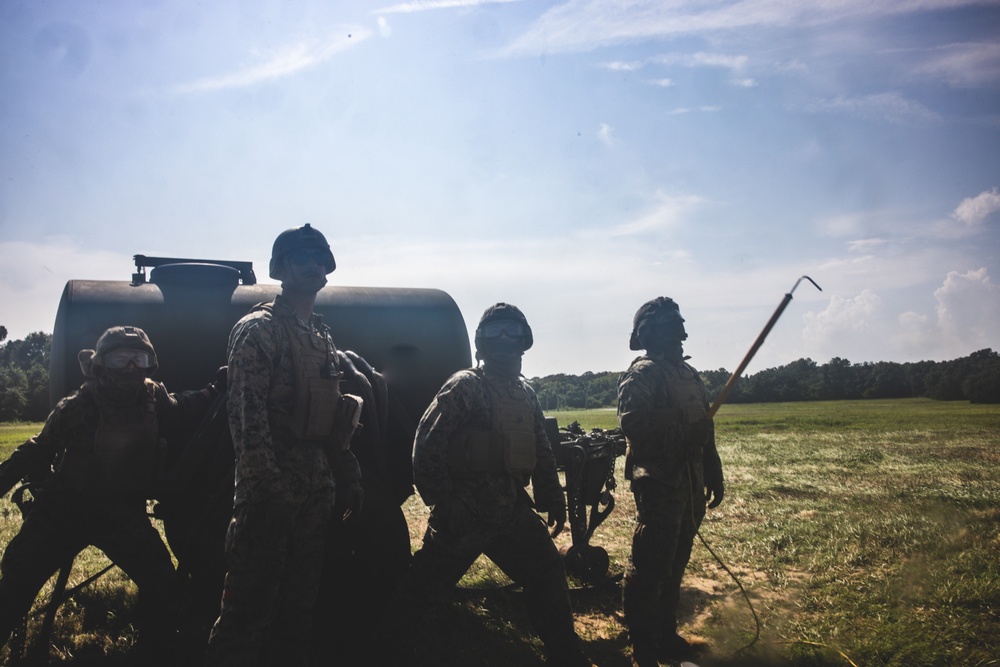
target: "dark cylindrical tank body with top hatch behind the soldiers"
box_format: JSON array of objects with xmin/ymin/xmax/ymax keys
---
[{"xmin": 49, "ymin": 261, "xmax": 472, "ymax": 421}]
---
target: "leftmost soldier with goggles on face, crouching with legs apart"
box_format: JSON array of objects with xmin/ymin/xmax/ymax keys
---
[{"xmin": 0, "ymin": 326, "xmax": 225, "ymax": 659}]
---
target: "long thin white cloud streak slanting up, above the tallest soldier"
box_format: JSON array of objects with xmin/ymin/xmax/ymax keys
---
[{"xmin": 173, "ymin": 26, "xmax": 372, "ymax": 94}]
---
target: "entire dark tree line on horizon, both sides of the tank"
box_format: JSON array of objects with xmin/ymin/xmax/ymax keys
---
[{"xmin": 0, "ymin": 326, "xmax": 1000, "ymax": 422}]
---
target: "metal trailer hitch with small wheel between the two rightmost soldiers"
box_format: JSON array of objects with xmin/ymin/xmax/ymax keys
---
[{"xmin": 545, "ymin": 417, "xmax": 625, "ymax": 584}]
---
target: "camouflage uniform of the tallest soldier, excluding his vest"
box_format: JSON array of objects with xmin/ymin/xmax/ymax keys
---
[{"xmin": 208, "ymin": 295, "xmax": 360, "ymax": 667}]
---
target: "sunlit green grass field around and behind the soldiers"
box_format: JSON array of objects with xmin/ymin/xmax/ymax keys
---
[{"xmin": 0, "ymin": 400, "xmax": 1000, "ymax": 667}]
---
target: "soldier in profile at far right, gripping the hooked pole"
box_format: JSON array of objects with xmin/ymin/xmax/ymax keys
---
[{"xmin": 618, "ymin": 297, "xmax": 724, "ymax": 667}]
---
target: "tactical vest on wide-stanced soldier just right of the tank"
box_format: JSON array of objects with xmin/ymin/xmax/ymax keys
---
[{"xmin": 448, "ymin": 368, "xmax": 537, "ymax": 484}]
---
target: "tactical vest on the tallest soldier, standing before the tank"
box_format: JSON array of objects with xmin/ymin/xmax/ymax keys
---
[{"xmin": 263, "ymin": 304, "xmax": 349, "ymax": 444}]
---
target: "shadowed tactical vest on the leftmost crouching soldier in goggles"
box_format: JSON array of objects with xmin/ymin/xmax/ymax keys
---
[{"xmin": 59, "ymin": 379, "xmax": 166, "ymax": 498}]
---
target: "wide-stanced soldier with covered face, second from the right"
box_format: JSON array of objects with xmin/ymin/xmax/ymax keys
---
[{"xmin": 392, "ymin": 303, "xmax": 591, "ymax": 667}]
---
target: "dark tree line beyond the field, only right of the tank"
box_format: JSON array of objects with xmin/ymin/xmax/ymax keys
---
[{"xmin": 531, "ymin": 348, "xmax": 1000, "ymax": 410}]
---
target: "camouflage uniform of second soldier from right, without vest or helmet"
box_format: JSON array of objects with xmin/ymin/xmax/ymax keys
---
[{"xmin": 401, "ymin": 369, "xmax": 590, "ymax": 666}]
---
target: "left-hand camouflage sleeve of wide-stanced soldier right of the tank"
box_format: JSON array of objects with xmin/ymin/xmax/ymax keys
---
[{"xmin": 413, "ymin": 372, "xmax": 477, "ymax": 505}]
